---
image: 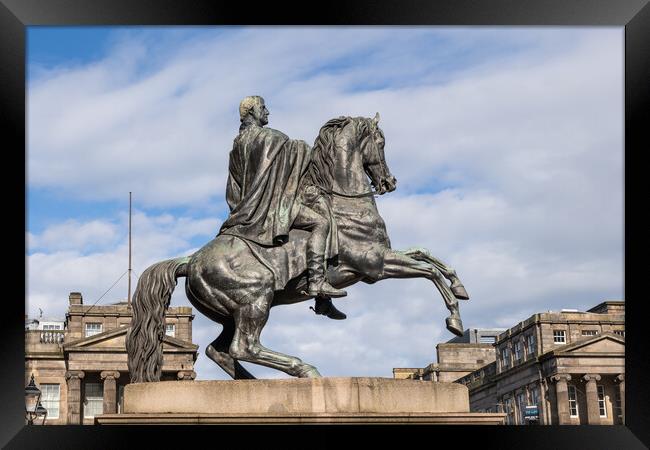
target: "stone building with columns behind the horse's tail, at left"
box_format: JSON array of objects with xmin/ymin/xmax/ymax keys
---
[{"xmin": 25, "ymin": 292, "xmax": 198, "ymax": 425}]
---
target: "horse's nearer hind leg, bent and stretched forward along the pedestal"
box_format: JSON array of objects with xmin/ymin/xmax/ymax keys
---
[{"xmin": 230, "ymin": 292, "xmax": 320, "ymax": 378}]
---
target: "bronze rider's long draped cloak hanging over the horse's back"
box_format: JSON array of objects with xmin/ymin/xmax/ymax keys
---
[{"xmin": 219, "ymin": 124, "xmax": 338, "ymax": 289}]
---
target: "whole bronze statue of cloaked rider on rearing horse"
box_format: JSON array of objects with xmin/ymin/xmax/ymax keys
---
[{"xmin": 126, "ymin": 98, "xmax": 469, "ymax": 383}]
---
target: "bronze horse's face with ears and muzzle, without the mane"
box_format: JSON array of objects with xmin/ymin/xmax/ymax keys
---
[{"xmin": 360, "ymin": 113, "xmax": 397, "ymax": 195}]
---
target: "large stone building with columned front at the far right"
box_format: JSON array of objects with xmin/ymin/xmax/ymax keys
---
[{"xmin": 458, "ymin": 301, "xmax": 625, "ymax": 425}]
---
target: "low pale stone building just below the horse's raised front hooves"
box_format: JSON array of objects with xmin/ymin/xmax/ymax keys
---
[{"xmin": 393, "ymin": 328, "xmax": 505, "ymax": 382}]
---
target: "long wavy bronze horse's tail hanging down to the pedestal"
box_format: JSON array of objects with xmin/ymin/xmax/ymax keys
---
[{"xmin": 126, "ymin": 256, "xmax": 190, "ymax": 383}]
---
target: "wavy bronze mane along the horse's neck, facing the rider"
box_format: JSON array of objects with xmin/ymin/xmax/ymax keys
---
[{"xmin": 303, "ymin": 116, "xmax": 370, "ymax": 192}]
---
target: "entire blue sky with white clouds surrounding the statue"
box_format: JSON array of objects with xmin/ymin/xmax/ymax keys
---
[{"xmin": 26, "ymin": 27, "xmax": 623, "ymax": 379}]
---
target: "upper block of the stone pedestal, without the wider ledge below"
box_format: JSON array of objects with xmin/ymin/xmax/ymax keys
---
[{"xmin": 124, "ymin": 378, "xmax": 469, "ymax": 415}]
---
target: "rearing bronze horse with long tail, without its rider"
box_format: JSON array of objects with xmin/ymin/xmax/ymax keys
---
[{"xmin": 126, "ymin": 114, "xmax": 469, "ymax": 383}]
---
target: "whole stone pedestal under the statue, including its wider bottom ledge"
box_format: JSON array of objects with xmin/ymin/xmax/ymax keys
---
[{"xmin": 96, "ymin": 378, "xmax": 505, "ymax": 424}]
